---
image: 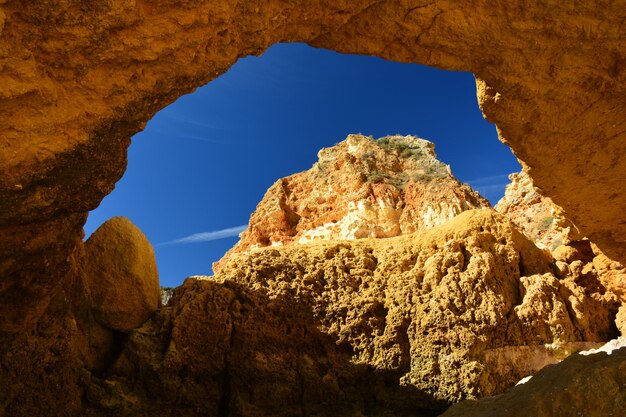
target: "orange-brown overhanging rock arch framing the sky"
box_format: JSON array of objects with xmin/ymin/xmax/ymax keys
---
[{"xmin": 0, "ymin": 0, "xmax": 626, "ymax": 332}]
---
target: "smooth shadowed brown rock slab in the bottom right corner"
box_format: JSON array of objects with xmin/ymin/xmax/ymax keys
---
[{"xmin": 441, "ymin": 349, "xmax": 626, "ymax": 417}]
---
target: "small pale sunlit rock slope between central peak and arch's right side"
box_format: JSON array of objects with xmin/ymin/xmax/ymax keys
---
[{"xmin": 495, "ymin": 171, "xmax": 583, "ymax": 251}]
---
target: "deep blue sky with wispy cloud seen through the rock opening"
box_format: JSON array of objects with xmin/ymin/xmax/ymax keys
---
[{"xmin": 85, "ymin": 44, "xmax": 520, "ymax": 286}]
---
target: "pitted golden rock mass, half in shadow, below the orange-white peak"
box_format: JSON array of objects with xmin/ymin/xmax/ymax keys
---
[{"xmin": 88, "ymin": 209, "xmax": 616, "ymax": 416}]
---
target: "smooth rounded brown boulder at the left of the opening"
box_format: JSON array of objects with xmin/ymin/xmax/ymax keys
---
[{"xmin": 81, "ymin": 217, "xmax": 161, "ymax": 331}]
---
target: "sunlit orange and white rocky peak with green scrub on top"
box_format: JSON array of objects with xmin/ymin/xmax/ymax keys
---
[{"xmin": 213, "ymin": 135, "xmax": 490, "ymax": 272}]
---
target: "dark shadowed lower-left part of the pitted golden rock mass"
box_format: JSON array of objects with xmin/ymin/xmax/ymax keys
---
[{"xmin": 87, "ymin": 278, "xmax": 447, "ymax": 416}]
